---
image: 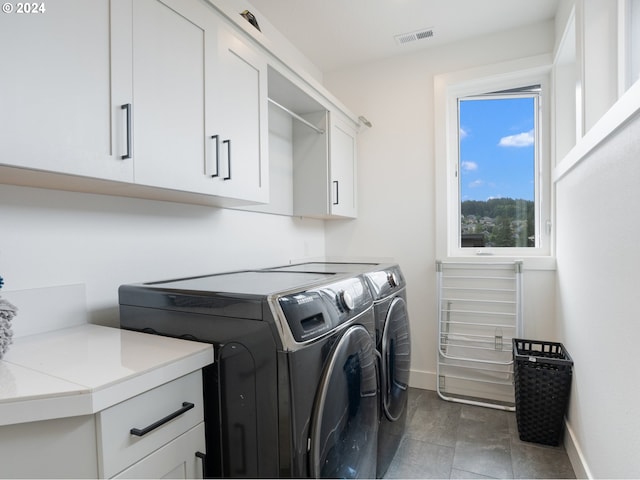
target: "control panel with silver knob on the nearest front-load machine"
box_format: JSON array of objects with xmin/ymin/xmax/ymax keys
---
[{"xmin": 278, "ymin": 277, "xmax": 373, "ymax": 342}]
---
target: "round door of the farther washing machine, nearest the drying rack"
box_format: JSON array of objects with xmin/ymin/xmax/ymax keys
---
[{"xmin": 381, "ymin": 297, "xmax": 411, "ymax": 421}]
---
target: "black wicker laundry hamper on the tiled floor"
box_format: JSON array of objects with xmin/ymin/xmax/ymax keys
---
[{"xmin": 513, "ymin": 338, "xmax": 573, "ymax": 446}]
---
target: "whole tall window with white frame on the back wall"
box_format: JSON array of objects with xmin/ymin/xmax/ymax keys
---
[{"xmin": 435, "ymin": 57, "xmax": 551, "ymax": 259}]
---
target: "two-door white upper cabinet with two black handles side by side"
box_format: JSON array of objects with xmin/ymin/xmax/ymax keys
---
[{"xmin": 121, "ymin": 0, "xmax": 268, "ymax": 202}]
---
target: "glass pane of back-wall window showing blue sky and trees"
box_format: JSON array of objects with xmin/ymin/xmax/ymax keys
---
[{"xmin": 458, "ymin": 85, "xmax": 540, "ymax": 248}]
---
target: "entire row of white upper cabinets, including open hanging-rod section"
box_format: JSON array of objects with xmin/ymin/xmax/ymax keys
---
[{"xmin": 0, "ymin": 0, "xmax": 358, "ymax": 213}]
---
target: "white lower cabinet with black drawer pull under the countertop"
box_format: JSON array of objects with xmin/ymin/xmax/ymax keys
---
[{"xmin": 0, "ymin": 370, "xmax": 206, "ymax": 478}]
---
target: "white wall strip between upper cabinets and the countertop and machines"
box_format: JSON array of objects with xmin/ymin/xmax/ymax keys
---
[{"xmin": 0, "ymin": 185, "xmax": 325, "ymax": 326}]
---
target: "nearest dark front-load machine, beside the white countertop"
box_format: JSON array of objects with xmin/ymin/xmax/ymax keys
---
[{"xmin": 119, "ymin": 271, "xmax": 379, "ymax": 478}]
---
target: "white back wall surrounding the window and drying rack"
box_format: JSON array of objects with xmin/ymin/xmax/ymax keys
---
[{"xmin": 324, "ymin": 22, "xmax": 554, "ymax": 389}]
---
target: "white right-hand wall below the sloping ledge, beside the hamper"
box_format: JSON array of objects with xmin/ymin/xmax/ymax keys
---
[{"xmin": 556, "ymin": 111, "xmax": 640, "ymax": 478}]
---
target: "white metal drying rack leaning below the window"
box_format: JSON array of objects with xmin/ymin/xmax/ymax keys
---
[{"xmin": 436, "ymin": 261, "xmax": 523, "ymax": 411}]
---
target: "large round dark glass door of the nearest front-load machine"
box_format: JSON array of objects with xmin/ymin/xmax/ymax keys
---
[{"xmin": 309, "ymin": 325, "xmax": 378, "ymax": 478}]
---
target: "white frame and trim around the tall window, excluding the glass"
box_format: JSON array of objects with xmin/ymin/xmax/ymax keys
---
[{"xmin": 434, "ymin": 55, "xmax": 553, "ymax": 260}]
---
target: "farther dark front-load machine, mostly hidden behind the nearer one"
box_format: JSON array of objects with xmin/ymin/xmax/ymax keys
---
[{"xmin": 264, "ymin": 262, "xmax": 411, "ymax": 478}]
